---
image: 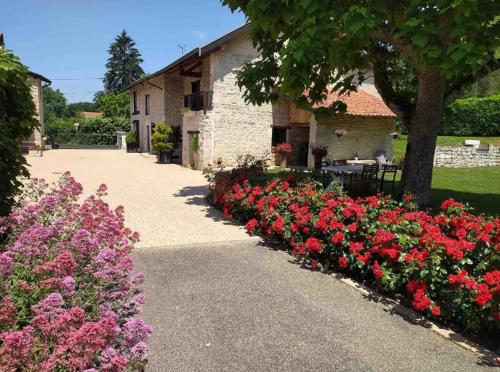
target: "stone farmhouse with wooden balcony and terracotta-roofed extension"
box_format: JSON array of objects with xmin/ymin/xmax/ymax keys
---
[{"xmin": 126, "ymin": 25, "xmax": 396, "ymax": 169}]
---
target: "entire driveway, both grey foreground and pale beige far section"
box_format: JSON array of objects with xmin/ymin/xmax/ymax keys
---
[{"xmin": 29, "ymin": 150, "xmax": 492, "ymax": 371}]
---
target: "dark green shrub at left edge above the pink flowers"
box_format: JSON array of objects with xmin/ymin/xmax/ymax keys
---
[{"xmin": 0, "ymin": 48, "xmax": 39, "ymax": 215}]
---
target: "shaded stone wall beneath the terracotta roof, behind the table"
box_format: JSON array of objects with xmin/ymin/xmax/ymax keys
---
[{"xmin": 316, "ymin": 116, "xmax": 395, "ymax": 159}]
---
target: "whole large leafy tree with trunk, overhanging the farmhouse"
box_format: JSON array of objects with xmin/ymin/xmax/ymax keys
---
[{"xmin": 222, "ymin": 0, "xmax": 500, "ymax": 204}]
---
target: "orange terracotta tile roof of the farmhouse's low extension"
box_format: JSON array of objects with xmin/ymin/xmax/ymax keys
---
[{"xmin": 313, "ymin": 91, "xmax": 396, "ymax": 118}]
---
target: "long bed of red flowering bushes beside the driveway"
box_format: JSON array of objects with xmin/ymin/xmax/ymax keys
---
[{"xmin": 214, "ymin": 179, "xmax": 500, "ymax": 331}]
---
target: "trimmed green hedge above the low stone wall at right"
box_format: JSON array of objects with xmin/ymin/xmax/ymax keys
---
[{"xmin": 442, "ymin": 94, "xmax": 500, "ymax": 136}]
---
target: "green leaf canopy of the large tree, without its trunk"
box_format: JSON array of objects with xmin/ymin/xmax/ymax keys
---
[{"xmin": 222, "ymin": 0, "xmax": 499, "ymax": 109}]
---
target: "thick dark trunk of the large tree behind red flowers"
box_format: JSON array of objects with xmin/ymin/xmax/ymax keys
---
[{"xmin": 401, "ymin": 70, "xmax": 445, "ymax": 206}]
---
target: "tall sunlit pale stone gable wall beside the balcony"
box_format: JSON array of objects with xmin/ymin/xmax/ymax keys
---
[{"xmin": 200, "ymin": 33, "xmax": 273, "ymax": 166}]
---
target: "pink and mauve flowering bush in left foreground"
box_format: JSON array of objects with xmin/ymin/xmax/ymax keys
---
[{"xmin": 0, "ymin": 173, "xmax": 152, "ymax": 371}]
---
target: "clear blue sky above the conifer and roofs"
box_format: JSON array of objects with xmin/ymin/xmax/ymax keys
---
[{"xmin": 0, "ymin": 0, "xmax": 245, "ymax": 102}]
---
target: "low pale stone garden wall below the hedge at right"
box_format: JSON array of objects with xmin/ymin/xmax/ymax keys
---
[{"xmin": 434, "ymin": 145, "xmax": 500, "ymax": 168}]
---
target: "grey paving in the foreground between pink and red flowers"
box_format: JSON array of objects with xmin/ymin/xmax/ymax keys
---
[{"xmin": 134, "ymin": 241, "xmax": 488, "ymax": 371}]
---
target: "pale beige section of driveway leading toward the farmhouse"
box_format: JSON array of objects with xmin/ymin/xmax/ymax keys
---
[{"xmin": 28, "ymin": 150, "xmax": 251, "ymax": 247}]
